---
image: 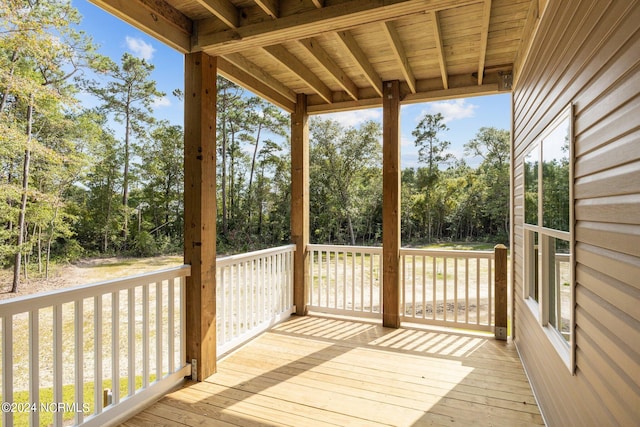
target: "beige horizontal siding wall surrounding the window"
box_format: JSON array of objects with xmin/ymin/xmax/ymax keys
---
[{"xmin": 512, "ymin": 0, "xmax": 640, "ymax": 426}]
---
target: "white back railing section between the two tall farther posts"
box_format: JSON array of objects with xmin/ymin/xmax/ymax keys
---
[{"xmin": 307, "ymin": 245, "xmax": 382, "ymax": 317}]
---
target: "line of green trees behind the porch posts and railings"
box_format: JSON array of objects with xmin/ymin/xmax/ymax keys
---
[{"xmin": 0, "ymin": 0, "xmax": 509, "ymax": 291}]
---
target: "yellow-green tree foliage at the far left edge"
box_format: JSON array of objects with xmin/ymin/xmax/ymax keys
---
[{"xmin": 0, "ymin": 0, "xmax": 104, "ymax": 291}]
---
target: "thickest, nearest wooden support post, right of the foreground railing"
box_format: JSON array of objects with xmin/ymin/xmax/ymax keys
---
[{"xmin": 184, "ymin": 52, "xmax": 217, "ymax": 381}]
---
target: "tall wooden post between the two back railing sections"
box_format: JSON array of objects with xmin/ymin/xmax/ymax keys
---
[{"xmin": 382, "ymin": 80, "xmax": 400, "ymax": 328}]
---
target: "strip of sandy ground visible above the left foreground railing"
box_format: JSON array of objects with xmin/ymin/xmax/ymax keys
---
[{"xmin": 0, "ymin": 255, "xmax": 182, "ymax": 300}]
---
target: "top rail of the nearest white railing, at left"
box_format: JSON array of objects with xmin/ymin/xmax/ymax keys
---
[{"xmin": 0, "ymin": 265, "xmax": 191, "ymax": 317}]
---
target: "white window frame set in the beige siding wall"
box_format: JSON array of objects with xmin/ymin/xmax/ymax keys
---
[{"xmin": 522, "ymin": 104, "xmax": 576, "ymax": 374}]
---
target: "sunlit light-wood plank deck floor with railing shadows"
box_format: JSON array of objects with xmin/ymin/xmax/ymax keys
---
[{"xmin": 123, "ymin": 316, "xmax": 543, "ymax": 426}]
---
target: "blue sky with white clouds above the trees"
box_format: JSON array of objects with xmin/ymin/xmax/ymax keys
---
[{"xmin": 72, "ymin": 0, "xmax": 511, "ymax": 168}]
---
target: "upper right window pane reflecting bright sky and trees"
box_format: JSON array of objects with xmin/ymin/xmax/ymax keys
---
[{"xmin": 542, "ymin": 118, "xmax": 569, "ymax": 231}]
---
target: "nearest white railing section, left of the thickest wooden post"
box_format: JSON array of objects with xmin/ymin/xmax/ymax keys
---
[{"xmin": 0, "ymin": 266, "xmax": 191, "ymax": 427}]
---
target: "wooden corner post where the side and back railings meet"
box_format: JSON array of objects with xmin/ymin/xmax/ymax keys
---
[{"xmin": 291, "ymin": 94, "xmax": 309, "ymax": 316}]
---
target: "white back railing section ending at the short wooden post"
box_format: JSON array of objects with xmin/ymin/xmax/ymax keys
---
[{"xmin": 400, "ymin": 248, "xmax": 494, "ymax": 331}]
